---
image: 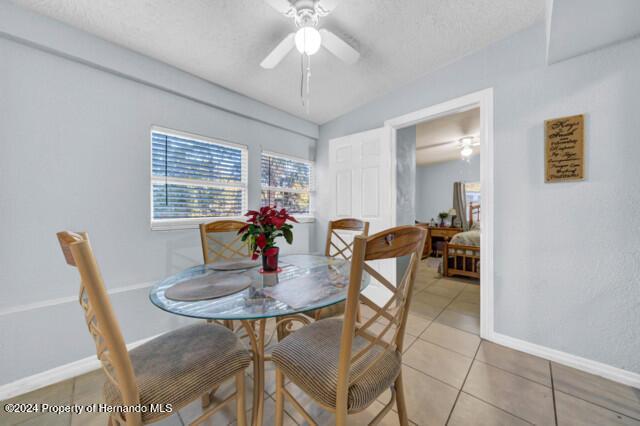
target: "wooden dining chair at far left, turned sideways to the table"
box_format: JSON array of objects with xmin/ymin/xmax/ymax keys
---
[{"xmin": 57, "ymin": 231, "xmax": 251, "ymax": 425}]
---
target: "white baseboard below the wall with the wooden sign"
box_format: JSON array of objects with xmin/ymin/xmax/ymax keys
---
[{"xmin": 485, "ymin": 332, "xmax": 640, "ymax": 389}]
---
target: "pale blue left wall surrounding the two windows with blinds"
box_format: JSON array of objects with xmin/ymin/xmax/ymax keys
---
[{"xmin": 0, "ymin": 3, "xmax": 315, "ymax": 384}]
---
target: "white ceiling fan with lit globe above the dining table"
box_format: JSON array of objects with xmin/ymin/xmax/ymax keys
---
[{"xmin": 260, "ymin": 0, "xmax": 360, "ymax": 69}]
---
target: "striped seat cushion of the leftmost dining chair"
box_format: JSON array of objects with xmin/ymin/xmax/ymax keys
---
[{"xmin": 104, "ymin": 323, "xmax": 251, "ymax": 422}]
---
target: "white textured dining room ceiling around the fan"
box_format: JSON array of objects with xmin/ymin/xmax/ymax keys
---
[{"xmin": 14, "ymin": 0, "xmax": 544, "ymax": 124}]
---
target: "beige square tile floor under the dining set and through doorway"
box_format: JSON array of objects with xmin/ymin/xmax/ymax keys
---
[{"xmin": 0, "ymin": 264, "xmax": 640, "ymax": 426}]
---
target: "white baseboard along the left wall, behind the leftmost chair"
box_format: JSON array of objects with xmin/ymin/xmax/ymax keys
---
[{"xmin": 0, "ymin": 333, "xmax": 162, "ymax": 401}]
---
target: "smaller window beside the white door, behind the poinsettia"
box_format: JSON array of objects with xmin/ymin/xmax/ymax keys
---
[{"xmin": 261, "ymin": 152, "xmax": 313, "ymax": 215}]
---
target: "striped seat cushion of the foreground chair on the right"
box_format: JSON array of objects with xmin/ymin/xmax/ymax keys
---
[{"xmin": 272, "ymin": 318, "xmax": 401, "ymax": 412}]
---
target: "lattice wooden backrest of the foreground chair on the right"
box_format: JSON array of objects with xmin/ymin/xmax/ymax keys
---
[{"xmin": 336, "ymin": 226, "xmax": 427, "ymax": 412}]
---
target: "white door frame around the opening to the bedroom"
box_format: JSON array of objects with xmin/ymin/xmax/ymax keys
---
[{"xmin": 384, "ymin": 88, "xmax": 494, "ymax": 339}]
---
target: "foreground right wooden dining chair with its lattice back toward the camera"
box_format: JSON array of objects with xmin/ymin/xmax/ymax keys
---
[{"xmin": 272, "ymin": 226, "xmax": 427, "ymax": 426}]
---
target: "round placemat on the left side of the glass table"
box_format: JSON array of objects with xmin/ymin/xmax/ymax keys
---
[{"xmin": 164, "ymin": 274, "xmax": 251, "ymax": 302}]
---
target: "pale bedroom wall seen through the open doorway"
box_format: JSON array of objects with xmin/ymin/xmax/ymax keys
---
[{"xmin": 416, "ymin": 155, "xmax": 480, "ymax": 223}]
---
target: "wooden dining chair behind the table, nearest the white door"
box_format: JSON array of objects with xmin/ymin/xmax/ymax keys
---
[{"xmin": 306, "ymin": 218, "xmax": 369, "ymax": 321}]
